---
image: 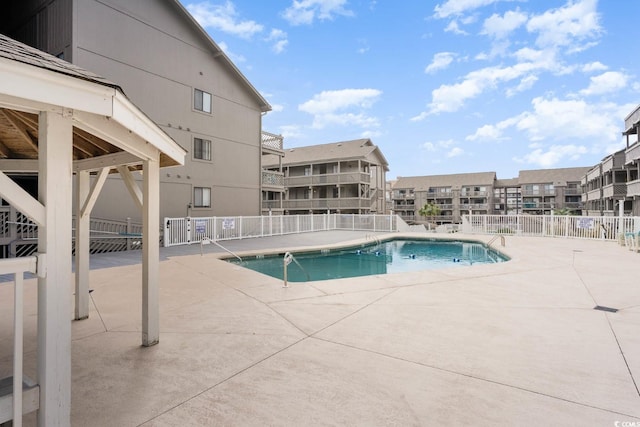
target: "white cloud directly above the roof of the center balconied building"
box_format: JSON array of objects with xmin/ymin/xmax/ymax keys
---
[{"xmin": 298, "ymin": 89, "xmax": 382, "ymax": 129}]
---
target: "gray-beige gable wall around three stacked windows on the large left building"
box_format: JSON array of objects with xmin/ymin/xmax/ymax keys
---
[{"xmin": 74, "ymin": 0, "xmax": 262, "ymax": 219}]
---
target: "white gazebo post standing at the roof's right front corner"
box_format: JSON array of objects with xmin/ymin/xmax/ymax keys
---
[{"xmin": 142, "ymin": 154, "xmax": 160, "ymax": 347}]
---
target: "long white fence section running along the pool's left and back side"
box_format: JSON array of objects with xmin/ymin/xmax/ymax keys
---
[{"xmin": 164, "ymin": 214, "xmax": 398, "ymax": 247}]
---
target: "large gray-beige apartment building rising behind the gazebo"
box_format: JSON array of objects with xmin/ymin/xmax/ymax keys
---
[{"xmin": 0, "ymin": 0, "xmax": 272, "ymax": 220}]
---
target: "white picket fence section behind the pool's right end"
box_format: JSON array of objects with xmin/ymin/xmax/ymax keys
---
[{"xmin": 461, "ymin": 215, "xmax": 640, "ymax": 240}]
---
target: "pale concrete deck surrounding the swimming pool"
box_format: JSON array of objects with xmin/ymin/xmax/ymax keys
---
[{"xmin": 0, "ymin": 232, "xmax": 640, "ymax": 426}]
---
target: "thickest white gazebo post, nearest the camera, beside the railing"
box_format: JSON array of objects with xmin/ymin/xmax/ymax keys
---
[{"xmin": 38, "ymin": 111, "xmax": 72, "ymax": 426}]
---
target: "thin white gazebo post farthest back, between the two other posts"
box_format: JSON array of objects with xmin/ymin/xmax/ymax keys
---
[{"xmin": 74, "ymin": 171, "xmax": 90, "ymax": 320}]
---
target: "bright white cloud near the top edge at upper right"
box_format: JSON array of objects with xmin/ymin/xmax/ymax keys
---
[{"xmin": 527, "ymin": 0, "xmax": 602, "ymax": 49}]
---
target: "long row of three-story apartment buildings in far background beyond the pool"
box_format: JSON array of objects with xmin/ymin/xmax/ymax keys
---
[{"xmin": 392, "ymin": 167, "xmax": 589, "ymax": 224}]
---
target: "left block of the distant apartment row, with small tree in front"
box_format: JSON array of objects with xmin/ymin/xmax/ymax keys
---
[{"xmin": 392, "ymin": 172, "xmax": 496, "ymax": 224}]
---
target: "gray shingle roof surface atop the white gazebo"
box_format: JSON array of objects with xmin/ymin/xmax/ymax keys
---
[{"xmin": 0, "ymin": 34, "xmax": 124, "ymax": 93}]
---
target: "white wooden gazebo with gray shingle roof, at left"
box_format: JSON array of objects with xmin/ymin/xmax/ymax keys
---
[{"xmin": 0, "ymin": 35, "xmax": 185, "ymax": 426}]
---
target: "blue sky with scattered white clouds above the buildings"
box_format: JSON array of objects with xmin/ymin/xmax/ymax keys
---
[{"xmin": 181, "ymin": 0, "xmax": 640, "ymax": 179}]
